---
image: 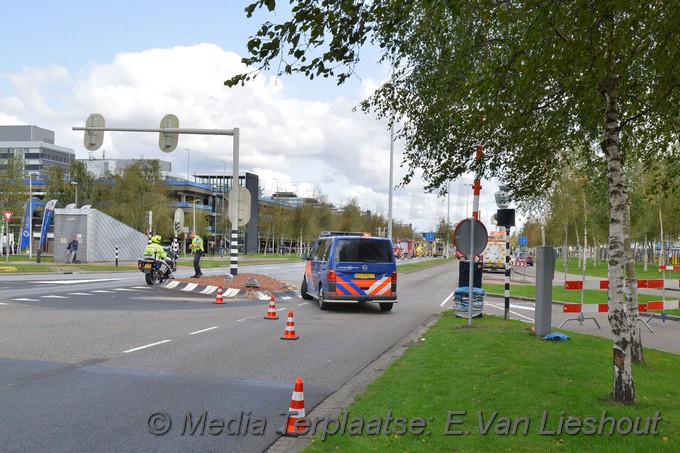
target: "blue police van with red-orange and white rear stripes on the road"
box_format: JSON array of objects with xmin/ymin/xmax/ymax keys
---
[{"xmin": 300, "ymin": 231, "xmax": 398, "ymax": 311}]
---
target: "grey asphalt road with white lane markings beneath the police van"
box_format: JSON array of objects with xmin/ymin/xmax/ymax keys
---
[{"xmin": 0, "ymin": 263, "xmax": 457, "ymax": 452}]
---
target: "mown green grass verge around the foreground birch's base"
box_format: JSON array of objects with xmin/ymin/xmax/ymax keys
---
[{"xmin": 304, "ymin": 311, "xmax": 680, "ymax": 452}]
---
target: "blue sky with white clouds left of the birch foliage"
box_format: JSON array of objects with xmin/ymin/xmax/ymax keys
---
[{"xmin": 0, "ymin": 0, "xmax": 510, "ymax": 232}]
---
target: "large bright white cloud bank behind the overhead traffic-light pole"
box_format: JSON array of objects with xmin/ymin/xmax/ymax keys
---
[{"xmin": 0, "ymin": 43, "xmax": 508, "ymax": 231}]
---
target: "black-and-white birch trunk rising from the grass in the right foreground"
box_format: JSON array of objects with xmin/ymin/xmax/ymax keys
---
[{"xmin": 601, "ymin": 84, "xmax": 635, "ymax": 404}]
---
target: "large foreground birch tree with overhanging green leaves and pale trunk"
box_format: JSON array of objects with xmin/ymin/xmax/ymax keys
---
[{"xmin": 230, "ymin": 0, "xmax": 680, "ymax": 404}]
